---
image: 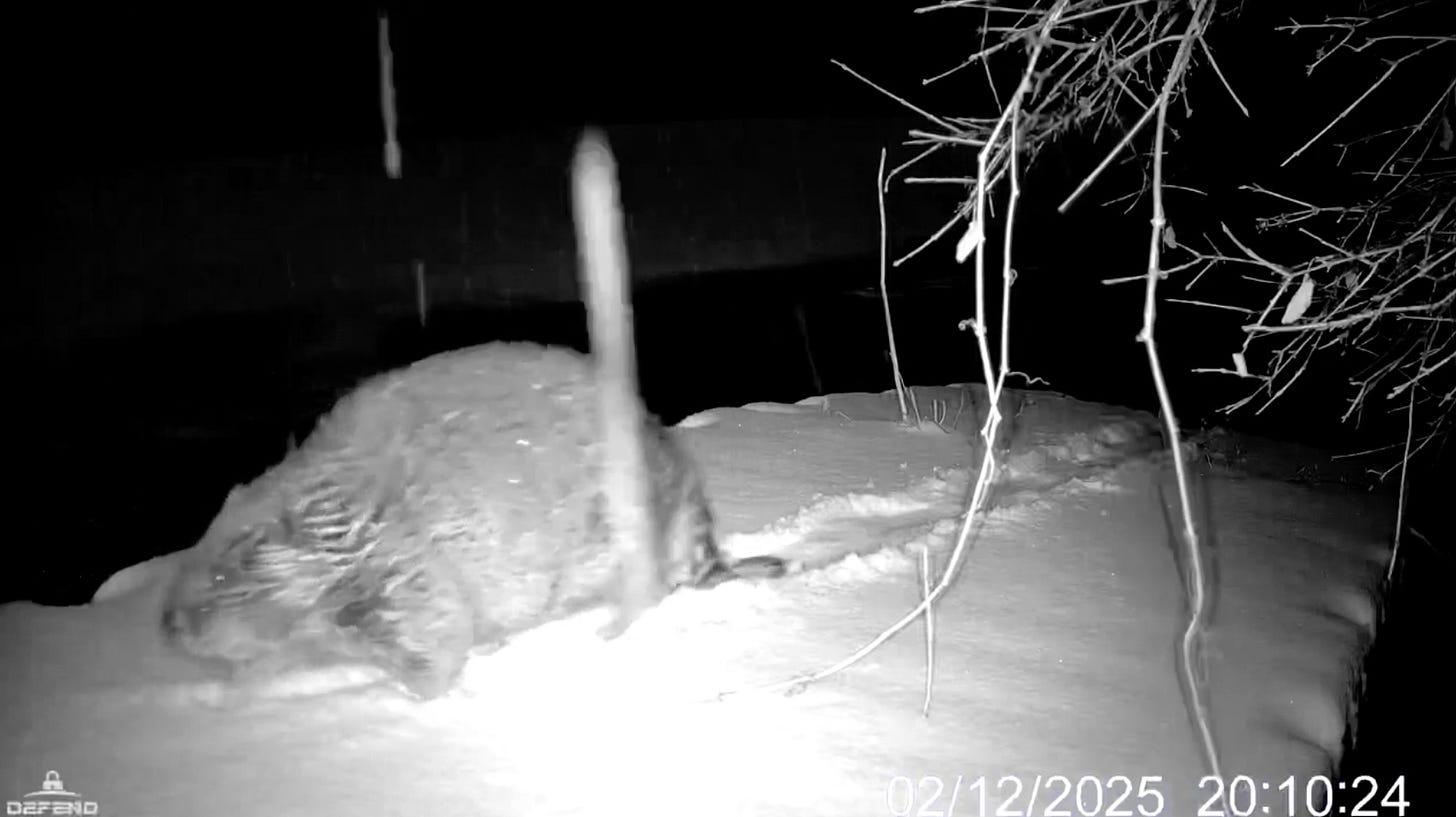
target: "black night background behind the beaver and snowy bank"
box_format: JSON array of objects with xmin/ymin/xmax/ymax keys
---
[{"xmin": 8, "ymin": 1, "xmax": 1450, "ymax": 798}]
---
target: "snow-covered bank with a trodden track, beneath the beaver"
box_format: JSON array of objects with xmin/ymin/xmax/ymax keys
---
[{"xmin": 0, "ymin": 387, "xmax": 1393, "ymax": 817}]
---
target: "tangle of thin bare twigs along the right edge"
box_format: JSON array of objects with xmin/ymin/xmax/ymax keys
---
[{"xmin": 1201, "ymin": 4, "xmax": 1456, "ymax": 476}]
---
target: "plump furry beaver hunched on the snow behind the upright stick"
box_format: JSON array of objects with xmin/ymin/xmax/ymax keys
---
[{"xmin": 162, "ymin": 344, "xmax": 785, "ymax": 698}]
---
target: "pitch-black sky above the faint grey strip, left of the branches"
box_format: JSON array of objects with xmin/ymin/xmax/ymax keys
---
[{"xmin": 17, "ymin": 0, "xmax": 954, "ymax": 169}]
